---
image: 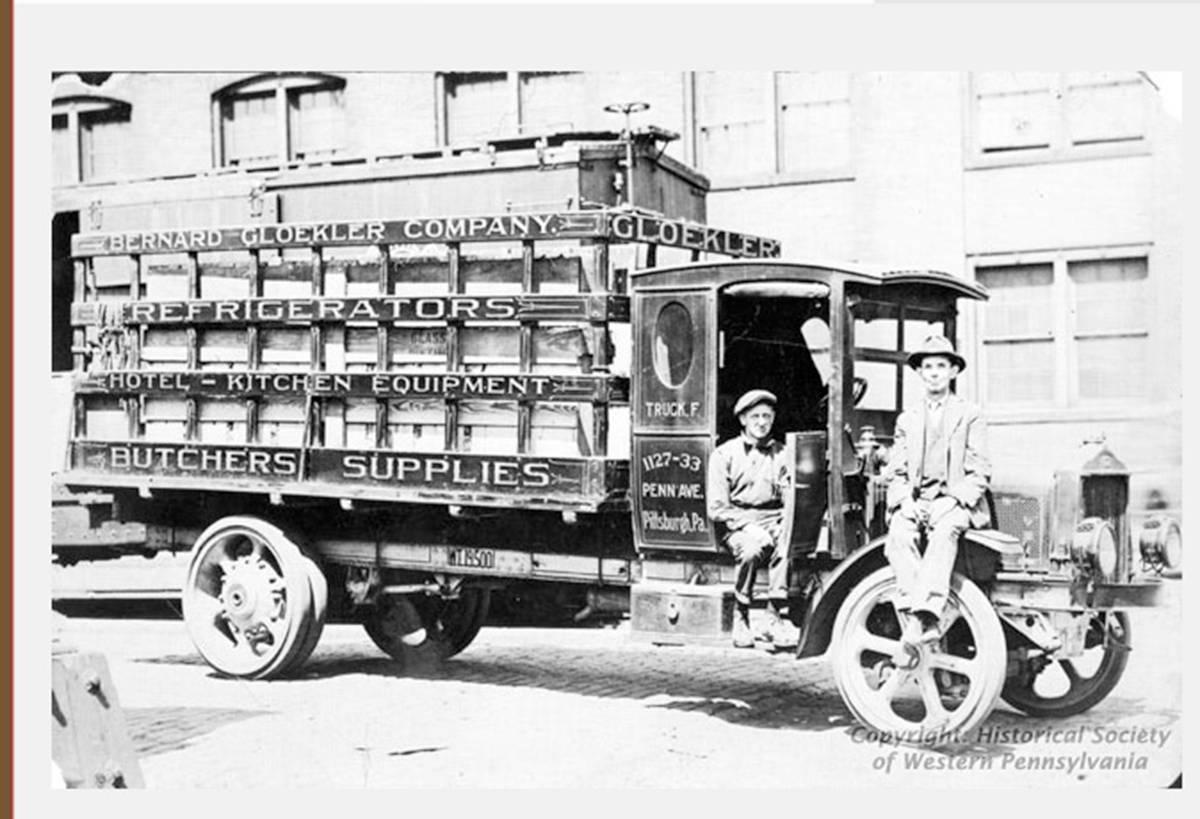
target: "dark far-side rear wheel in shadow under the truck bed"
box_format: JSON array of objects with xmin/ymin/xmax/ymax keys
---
[{"xmin": 362, "ymin": 588, "xmax": 491, "ymax": 663}]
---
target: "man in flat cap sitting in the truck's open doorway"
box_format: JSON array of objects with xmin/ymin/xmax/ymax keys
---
[{"xmin": 708, "ymin": 389, "xmax": 797, "ymax": 648}]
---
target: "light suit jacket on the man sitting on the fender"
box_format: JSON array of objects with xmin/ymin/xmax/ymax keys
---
[{"xmin": 888, "ymin": 393, "xmax": 991, "ymax": 528}]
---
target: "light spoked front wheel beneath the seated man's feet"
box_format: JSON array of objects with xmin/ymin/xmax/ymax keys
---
[{"xmin": 833, "ymin": 568, "xmax": 1007, "ymax": 745}]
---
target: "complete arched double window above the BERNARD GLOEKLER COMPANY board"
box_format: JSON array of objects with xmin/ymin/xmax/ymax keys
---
[{"xmin": 212, "ymin": 73, "xmax": 346, "ymax": 167}]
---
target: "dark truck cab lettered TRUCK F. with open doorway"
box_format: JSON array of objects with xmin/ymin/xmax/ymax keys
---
[{"xmin": 631, "ymin": 261, "xmax": 985, "ymax": 600}]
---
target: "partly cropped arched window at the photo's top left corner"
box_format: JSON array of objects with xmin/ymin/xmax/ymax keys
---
[{"xmin": 50, "ymin": 74, "xmax": 133, "ymax": 185}]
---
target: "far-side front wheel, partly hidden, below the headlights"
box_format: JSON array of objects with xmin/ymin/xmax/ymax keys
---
[{"xmin": 1001, "ymin": 611, "xmax": 1129, "ymax": 717}]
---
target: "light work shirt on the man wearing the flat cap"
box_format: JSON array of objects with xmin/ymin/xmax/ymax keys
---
[{"xmin": 708, "ymin": 434, "xmax": 792, "ymax": 531}]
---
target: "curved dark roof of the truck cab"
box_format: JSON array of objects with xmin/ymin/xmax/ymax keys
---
[{"xmin": 630, "ymin": 259, "xmax": 988, "ymax": 300}]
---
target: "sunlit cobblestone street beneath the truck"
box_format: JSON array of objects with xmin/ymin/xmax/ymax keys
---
[{"xmin": 54, "ymin": 576, "xmax": 1182, "ymax": 789}]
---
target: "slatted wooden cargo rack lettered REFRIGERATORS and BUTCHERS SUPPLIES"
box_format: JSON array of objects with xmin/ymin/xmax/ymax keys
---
[{"xmin": 64, "ymin": 209, "xmax": 779, "ymax": 512}]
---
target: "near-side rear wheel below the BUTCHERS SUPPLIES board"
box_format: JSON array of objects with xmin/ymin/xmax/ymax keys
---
[{"xmin": 182, "ymin": 516, "xmax": 328, "ymax": 680}]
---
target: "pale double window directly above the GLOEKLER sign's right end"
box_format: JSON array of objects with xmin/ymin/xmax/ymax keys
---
[{"xmin": 696, "ymin": 71, "xmax": 853, "ymax": 181}]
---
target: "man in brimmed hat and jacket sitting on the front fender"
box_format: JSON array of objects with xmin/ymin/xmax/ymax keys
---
[{"xmin": 884, "ymin": 335, "xmax": 991, "ymax": 641}]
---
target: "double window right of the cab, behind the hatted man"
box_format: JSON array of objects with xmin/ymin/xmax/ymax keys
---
[{"xmin": 976, "ymin": 248, "xmax": 1151, "ymax": 407}]
